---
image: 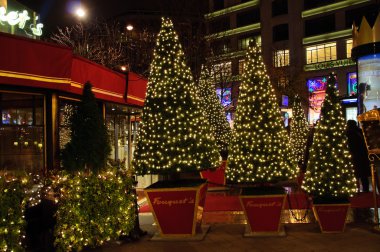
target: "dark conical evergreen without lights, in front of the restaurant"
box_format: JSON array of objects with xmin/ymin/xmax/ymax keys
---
[{"xmin": 62, "ymin": 82, "xmax": 111, "ymax": 172}]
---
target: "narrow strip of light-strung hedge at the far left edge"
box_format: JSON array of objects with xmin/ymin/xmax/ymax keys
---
[{"xmin": 0, "ymin": 176, "xmax": 26, "ymax": 251}]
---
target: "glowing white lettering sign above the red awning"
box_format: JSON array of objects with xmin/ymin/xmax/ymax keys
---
[{"xmin": 0, "ymin": 7, "xmax": 44, "ymax": 36}]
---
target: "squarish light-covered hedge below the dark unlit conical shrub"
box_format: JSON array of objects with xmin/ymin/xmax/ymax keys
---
[{"xmin": 54, "ymin": 170, "xmax": 136, "ymax": 251}]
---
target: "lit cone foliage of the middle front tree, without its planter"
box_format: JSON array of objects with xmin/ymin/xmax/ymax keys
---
[{"xmin": 227, "ymin": 41, "xmax": 295, "ymax": 183}]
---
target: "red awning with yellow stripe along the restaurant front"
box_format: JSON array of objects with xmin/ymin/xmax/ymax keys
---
[{"xmin": 0, "ymin": 33, "xmax": 147, "ymax": 106}]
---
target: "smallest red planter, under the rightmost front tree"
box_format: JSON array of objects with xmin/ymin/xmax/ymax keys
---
[{"xmin": 313, "ymin": 204, "xmax": 350, "ymax": 233}]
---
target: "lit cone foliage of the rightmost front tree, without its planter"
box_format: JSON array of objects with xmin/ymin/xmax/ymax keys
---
[{"xmin": 302, "ymin": 74, "xmax": 356, "ymax": 200}]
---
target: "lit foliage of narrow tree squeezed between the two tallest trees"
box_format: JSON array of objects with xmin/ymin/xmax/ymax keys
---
[{"xmin": 198, "ymin": 67, "xmax": 232, "ymax": 158}]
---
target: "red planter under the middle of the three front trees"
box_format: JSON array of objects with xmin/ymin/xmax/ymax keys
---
[{"xmin": 240, "ymin": 194, "xmax": 286, "ymax": 234}]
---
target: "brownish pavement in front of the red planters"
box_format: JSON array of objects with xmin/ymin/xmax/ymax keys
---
[{"xmin": 95, "ymin": 214, "xmax": 380, "ymax": 252}]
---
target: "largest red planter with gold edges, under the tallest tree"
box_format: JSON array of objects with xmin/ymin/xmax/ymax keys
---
[{"xmin": 144, "ymin": 180, "xmax": 207, "ymax": 238}]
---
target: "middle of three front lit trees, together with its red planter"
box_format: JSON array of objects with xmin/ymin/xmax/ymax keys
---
[{"xmin": 226, "ymin": 43, "xmax": 296, "ymax": 236}]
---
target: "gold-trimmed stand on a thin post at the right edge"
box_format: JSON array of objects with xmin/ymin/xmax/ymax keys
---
[{"xmin": 358, "ymin": 109, "xmax": 380, "ymax": 233}]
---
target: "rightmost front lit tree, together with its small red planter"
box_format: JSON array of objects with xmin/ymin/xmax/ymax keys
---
[{"xmin": 302, "ymin": 74, "xmax": 356, "ymax": 232}]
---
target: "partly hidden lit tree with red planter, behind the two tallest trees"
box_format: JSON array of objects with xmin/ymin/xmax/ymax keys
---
[{"xmin": 198, "ymin": 66, "xmax": 232, "ymax": 188}]
